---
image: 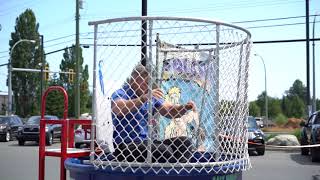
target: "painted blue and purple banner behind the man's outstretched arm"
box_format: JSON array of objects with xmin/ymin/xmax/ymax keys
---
[{"xmin": 159, "ymin": 58, "xmax": 214, "ymax": 150}]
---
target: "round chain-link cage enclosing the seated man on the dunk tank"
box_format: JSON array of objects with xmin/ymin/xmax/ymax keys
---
[{"xmin": 89, "ymin": 17, "xmax": 251, "ymax": 174}]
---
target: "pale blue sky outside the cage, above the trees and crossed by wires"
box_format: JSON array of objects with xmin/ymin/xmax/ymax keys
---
[{"xmin": 0, "ymin": 0, "xmax": 320, "ymax": 101}]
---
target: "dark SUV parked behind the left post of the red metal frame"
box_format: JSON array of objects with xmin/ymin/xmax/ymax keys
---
[{"xmin": 17, "ymin": 115, "xmax": 61, "ymax": 146}]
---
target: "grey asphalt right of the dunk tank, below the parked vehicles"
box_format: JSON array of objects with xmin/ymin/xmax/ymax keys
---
[{"xmin": 243, "ymin": 150, "xmax": 320, "ymax": 180}]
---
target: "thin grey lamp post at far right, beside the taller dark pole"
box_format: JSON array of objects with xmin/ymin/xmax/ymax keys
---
[{"xmin": 312, "ymin": 14, "xmax": 317, "ymax": 112}]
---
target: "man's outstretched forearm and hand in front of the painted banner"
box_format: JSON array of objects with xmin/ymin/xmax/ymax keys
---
[{"xmin": 159, "ymin": 101, "xmax": 196, "ymax": 118}]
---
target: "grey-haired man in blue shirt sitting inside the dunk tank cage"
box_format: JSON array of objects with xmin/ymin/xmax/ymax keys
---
[{"xmin": 111, "ymin": 64, "xmax": 196, "ymax": 163}]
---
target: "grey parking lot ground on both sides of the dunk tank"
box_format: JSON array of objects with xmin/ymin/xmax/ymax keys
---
[{"xmin": 0, "ymin": 141, "xmax": 320, "ymax": 180}]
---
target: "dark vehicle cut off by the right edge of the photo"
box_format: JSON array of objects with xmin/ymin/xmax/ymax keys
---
[{"xmin": 300, "ymin": 111, "xmax": 320, "ymax": 162}]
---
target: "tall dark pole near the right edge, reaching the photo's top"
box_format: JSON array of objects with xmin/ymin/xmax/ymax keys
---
[{"xmin": 306, "ymin": 0, "xmax": 311, "ymax": 115}]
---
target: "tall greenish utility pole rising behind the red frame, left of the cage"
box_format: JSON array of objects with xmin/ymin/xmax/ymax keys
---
[{"xmin": 74, "ymin": 0, "xmax": 80, "ymax": 118}]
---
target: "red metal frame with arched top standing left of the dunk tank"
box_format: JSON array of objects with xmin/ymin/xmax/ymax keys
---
[{"xmin": 39, "ymin": 86, "xmax": 91, "ymax": 180}]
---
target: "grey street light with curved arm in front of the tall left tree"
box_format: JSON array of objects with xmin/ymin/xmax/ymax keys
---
[{"xmin": 8, "ymin": 39, "xmax": 36, "ymax": 116}]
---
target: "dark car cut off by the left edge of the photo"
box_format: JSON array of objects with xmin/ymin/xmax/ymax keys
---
[{"xmin": 0, "ymin": 116, "xmax": 23, "ymax": 142}]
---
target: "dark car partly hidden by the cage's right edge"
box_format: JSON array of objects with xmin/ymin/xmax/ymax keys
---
[{"xmin": 248, "ymin": 116, "xmax": 266, "ymax": 155}]
